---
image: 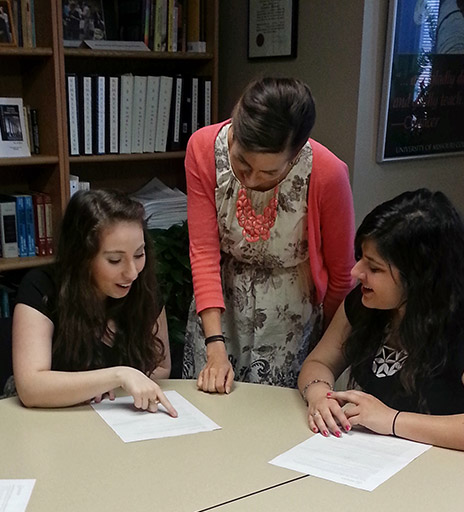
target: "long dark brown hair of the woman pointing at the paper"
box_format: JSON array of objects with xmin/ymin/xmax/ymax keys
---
[{"xmin": 53, "ymin": 190, "xmax": 164, "ymax": 375}]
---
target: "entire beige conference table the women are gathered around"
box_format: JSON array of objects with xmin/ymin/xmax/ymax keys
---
[{"xmin": 0, "ymin": 380, "xmax": 464, "ymax": 512}]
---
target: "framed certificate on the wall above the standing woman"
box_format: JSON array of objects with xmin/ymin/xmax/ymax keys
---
[{"xmin": 248, "ymin": 0, "xmax": 298, "ymax": 59}]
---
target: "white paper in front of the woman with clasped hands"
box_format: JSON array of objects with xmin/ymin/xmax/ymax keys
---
[{"xmin": 270, "ymin": 431, "xmax": 430, "ymax": 491}]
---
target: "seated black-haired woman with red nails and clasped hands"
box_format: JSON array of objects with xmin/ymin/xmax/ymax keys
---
[{"xmin": 298, "ymin": 189, "xmax": 464, "ymax": 450}]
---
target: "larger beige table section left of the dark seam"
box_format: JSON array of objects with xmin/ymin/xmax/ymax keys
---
[{"xmin": 0, "ymin": 380, "xmax": 308, "ymax": 512}]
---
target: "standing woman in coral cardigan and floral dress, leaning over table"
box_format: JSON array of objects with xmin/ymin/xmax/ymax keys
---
[{"xmin": 183, "ymin": 78, "xmax": 354, "ymax": 393}]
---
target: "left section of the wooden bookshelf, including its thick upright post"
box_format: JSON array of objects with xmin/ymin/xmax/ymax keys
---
[{"xmin": 0, "ymin": 0, "xmax": 69, "ymax": 273}]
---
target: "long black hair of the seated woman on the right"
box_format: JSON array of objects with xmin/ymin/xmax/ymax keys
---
[{"xmin": 345, "ymin": 188, "xmax": 464, "ymax": 407}]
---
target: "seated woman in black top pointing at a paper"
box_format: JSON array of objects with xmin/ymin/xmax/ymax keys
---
[{"xmin": 13, "ymin": 190, "xmax": 177, "ymax": 416}]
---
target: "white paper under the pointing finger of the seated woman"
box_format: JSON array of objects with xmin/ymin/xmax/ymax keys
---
[{"xmin": 92, "ymin": 391, "xmax": 221, "ymax": 443}]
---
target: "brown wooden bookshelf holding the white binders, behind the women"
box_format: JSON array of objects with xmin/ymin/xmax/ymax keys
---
[{"xmin": 0, "ymin": 0, "xmax": 218, "ymax": 273}]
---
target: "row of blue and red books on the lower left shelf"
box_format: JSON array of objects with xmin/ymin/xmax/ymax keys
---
[{"xmin": 0, "ymin": 192, "xmax": 53, "ymax": 258}]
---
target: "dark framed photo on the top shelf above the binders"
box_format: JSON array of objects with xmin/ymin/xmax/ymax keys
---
[{"xmin": 63, "ymin": 0, "xmax": 106, "ymax": 47}]
